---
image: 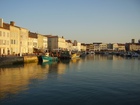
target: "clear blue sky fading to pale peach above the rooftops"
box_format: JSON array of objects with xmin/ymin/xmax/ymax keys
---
[{"xmin": 0, "ymin": 0, "xmax": 140, "ymax": 43}]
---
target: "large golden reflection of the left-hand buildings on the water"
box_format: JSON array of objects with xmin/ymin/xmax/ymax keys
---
[{"xmin": 0, "ymin": 63, "xmax": 49, "ymax": 98}]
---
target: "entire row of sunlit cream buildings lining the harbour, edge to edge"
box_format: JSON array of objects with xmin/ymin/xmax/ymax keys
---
[{"xmin": 0, "ymin": 19, "xmax": 140, "ymax": 55}]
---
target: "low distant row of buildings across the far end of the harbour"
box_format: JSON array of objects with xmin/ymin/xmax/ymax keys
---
[{"xmin": 86, "ymin": 39, "xmax": 140, "ymax": 51}]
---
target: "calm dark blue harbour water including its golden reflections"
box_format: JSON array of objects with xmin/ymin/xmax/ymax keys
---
[{"xmin": 0, "ymin": 55, "xmax": 140, "ymax": 105}]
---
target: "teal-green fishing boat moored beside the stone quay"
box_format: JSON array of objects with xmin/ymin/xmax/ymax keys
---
[{"xmin": 39, "ymin": 53, "xmax": 58, "ymax": 62}]
